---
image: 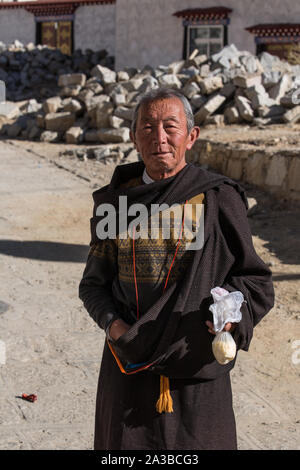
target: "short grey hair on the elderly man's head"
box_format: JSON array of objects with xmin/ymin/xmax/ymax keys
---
[{"xmin": 131, "ymin": 87, "xmax": 195, "ymax": 135}]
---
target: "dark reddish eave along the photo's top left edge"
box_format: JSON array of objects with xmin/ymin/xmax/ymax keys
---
[{"xmin": 0, "ymin": 0, "xmax": 116, "ymax": 16}]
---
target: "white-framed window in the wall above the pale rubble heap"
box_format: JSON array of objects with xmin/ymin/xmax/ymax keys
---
[{"xmin": 186, "ymin": 25, "xmax": 224, "ymax": 57}]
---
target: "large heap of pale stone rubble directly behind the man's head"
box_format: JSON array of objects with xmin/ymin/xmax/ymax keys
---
[{"xmin": 2, "ymin": 44, "xmax": 300, "ymax": 144}]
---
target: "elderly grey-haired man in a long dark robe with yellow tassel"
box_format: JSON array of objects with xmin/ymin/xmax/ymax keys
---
[{"xmin": 79, "ymin": 89, "xmax": 274, "ymax": 450}]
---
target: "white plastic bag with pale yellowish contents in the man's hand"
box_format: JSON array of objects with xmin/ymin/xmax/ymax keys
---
[{"xmin": 209, "ymin": 287, "xmax": 244, "ymax": 364}]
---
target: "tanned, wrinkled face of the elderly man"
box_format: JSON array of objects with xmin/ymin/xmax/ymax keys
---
[{"xmin": 131, "ymin": 97, "xmax": 199, "ymax": 180}]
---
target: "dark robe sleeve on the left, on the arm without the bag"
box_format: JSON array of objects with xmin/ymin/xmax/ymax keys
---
[{"xmin": 79, "ymin": 239, "xmax": 120, "ymax": 334}]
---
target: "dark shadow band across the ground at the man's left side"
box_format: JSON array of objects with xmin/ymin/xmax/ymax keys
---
[{"xmin": 0, "ymin": 240, "xmax": 89, "ymax": 263}]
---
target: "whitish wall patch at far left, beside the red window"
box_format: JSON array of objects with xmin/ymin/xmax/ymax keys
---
[{"xmin": 0, "ymin": 8, "xmax": 35, "ymax": 45}]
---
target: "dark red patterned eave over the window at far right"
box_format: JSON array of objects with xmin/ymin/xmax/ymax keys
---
[{"xmin": 245, "ymin": 23, "xmax": 300, "ymax": 43}]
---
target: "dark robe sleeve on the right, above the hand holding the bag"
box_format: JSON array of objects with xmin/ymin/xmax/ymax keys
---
[{"xmin": 218, "ymin": 185, "xmax": 274, "ymax": 351}]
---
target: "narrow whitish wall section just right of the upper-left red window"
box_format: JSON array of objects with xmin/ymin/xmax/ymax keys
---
[{"xmin": 74, "ymin": 4, "xmax": 116, "ymax": 55}]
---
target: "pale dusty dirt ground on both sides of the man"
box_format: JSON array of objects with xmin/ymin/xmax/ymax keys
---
[{"xmin": 0, "ymin": 127, "xmax": 300, "ymax": 450}]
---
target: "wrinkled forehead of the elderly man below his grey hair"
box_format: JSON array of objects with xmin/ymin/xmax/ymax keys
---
[{"xmin": 138, "ymin": 97, "xmax": 186, "ymax": 123}]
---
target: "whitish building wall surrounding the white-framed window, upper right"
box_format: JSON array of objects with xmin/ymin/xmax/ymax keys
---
[{"xmin": 115, "ymin": 0, "xmax": 300, "ymax": 70}]
